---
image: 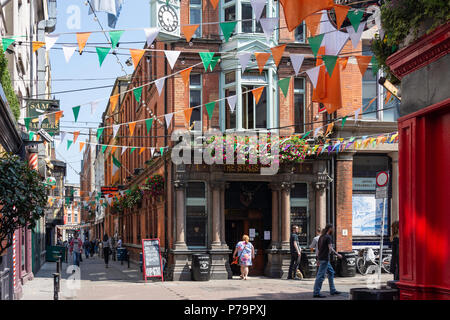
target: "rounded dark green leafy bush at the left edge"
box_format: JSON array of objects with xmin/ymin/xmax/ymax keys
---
[{"xmin": 0, "ymin": 153, "xmax": 47, "ymax": 254}]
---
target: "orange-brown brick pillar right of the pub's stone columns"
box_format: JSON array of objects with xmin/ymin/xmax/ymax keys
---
[{"xmin": 334, "ymin": 152, "xmax": 354, "ymax": 251}]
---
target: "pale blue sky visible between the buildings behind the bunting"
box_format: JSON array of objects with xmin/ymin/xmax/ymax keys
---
[{"xmin": 50, "ymin": 0, "xmax": 150, "ymax": 183}]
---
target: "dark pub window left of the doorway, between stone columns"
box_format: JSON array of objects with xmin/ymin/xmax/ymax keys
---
[{"xmin": 186, "ymin": 182, "xmax": 208, "ymax": 247}]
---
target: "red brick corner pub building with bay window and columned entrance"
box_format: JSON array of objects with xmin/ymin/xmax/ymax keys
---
[{"xmin": 99, "ymin": 0, "xmax": 396, "ymax": 280}]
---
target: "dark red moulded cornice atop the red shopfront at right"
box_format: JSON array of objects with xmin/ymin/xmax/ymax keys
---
[{"xmin": 386, "ymin": 22, "xmax": 450, "ymax": 79}]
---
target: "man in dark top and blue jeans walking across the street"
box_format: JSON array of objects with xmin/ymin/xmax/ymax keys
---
[{"xmin": 313, "ymin": 224, "xmax": 342, "ymax": 298}]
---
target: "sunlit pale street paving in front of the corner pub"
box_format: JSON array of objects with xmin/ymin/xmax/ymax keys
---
[{"xmin": 22, "ymin": 256, "xmax": 392, "ymax": 300}]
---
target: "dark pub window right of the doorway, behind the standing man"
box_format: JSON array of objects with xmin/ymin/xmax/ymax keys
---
[{"xmin": 291, "ymin": 183, "xmax": 309, "ymax": 245}]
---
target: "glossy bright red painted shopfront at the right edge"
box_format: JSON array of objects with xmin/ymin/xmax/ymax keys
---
[{"xmin": 387, "ymin": 23, "xmax": 450, "ymax": 300}]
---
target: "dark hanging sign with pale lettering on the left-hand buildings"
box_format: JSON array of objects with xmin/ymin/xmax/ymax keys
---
[{"xmin": 26, "ymin": 99, "xmax": 60, "ymax": 136}]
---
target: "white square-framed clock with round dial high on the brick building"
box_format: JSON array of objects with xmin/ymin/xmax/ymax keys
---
[{"xmin": 150, "ymin": 0, "xmax": 180, "ymax": 40}]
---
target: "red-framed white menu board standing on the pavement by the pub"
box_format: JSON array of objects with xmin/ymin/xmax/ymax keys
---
[{"xmin": 142, "ymin": 239, "xmax": 164, "ymax": 281}]
